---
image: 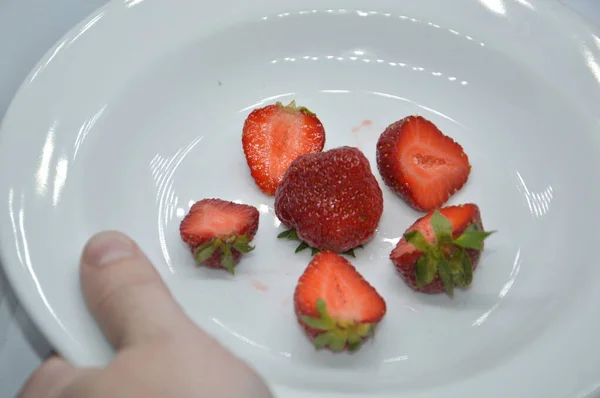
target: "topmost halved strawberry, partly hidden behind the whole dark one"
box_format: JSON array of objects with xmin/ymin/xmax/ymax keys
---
[{"xmin": 242, "ymin": 101, "xmax": 325, "ymax": 195}]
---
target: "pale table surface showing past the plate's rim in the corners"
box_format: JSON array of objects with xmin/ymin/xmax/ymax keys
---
[{"xmin": 0, "ymin": 0, "xmax": 600, "ymax": 398}]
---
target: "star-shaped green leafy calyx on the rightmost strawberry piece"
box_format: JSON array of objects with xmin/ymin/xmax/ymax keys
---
[{"xmin": 404, "ymin": 210, "xmax": 495, "ymax": 296}]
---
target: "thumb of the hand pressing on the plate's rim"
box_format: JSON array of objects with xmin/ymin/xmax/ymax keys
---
[{"xmin": 81, "ymin": 232, "xmax": 197, "ymax": 349}]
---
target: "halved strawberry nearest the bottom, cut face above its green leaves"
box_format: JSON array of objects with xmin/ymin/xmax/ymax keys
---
[{"xmin": 294, "ymin": 252, "xmax": 386, "ymax": 352}]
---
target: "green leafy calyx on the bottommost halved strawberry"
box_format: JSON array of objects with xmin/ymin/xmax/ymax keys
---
[{"xmin": 301, "ymin": 298, "xmax": 377, "ymax": 352}]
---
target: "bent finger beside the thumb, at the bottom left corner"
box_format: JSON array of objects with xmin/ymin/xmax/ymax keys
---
[{"xmin": 17, "ymin": 357, "xmax": 79, "ymax": 398}]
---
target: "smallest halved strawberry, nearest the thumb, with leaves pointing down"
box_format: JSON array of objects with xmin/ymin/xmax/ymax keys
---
[{"xmin": 179, "ymin": 199, "xmax": 259, "ymax": 274}]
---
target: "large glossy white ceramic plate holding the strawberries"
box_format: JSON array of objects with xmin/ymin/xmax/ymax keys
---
[{"xmin": 0, "ymin": 0, "xmax": 600, "ymax": 398}]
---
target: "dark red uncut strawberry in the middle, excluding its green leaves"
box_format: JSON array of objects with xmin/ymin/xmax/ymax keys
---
[{"xmin": 275, "ymin": 147, "xmax": 383, "ymax": 253}]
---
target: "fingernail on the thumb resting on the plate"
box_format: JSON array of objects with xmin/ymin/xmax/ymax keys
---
[{"xmin": 82, "ymin": 232, "xmax": 135, "ymax": 266}]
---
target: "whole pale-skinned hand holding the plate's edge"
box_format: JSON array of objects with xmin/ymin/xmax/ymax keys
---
[{"xmin": 18, "ymin": 232, "xmax": 272, "ymax": 398}]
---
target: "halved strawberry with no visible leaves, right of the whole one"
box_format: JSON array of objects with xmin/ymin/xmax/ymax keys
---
[{"xmin": 377, "ymin": 116, "xmax": 471, "ymax": 211}]
